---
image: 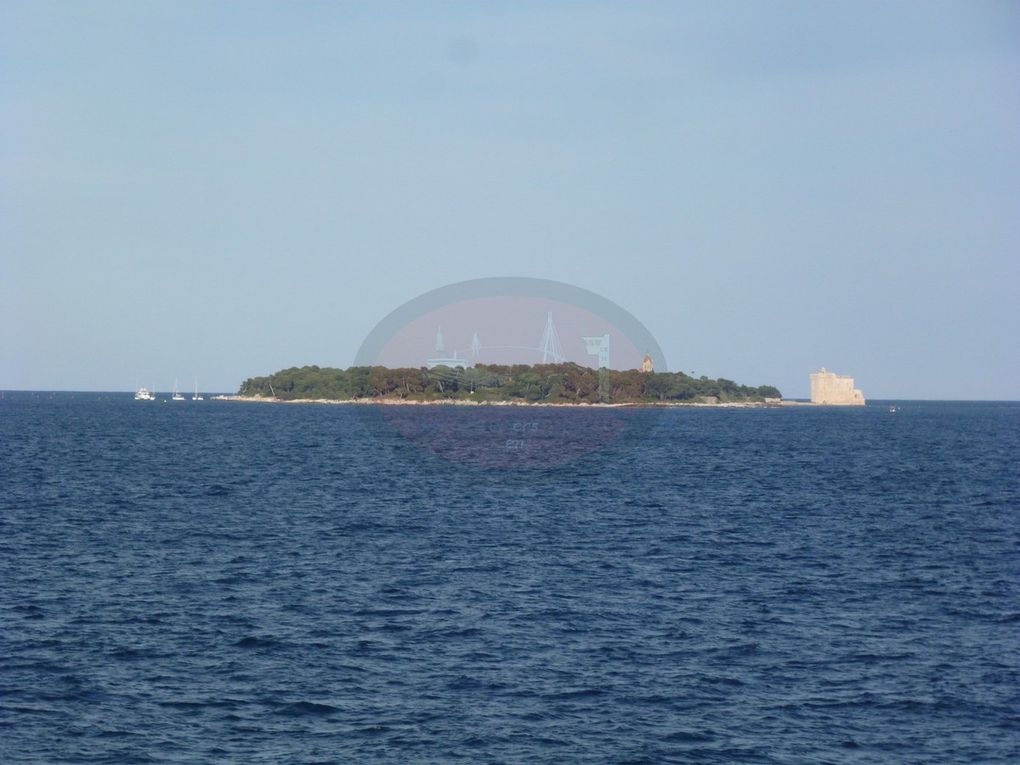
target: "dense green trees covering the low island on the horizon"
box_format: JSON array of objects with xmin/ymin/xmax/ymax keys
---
[{"xmin": 239, "ymin": 364, "xmax": 779, "ymax": 404}]
